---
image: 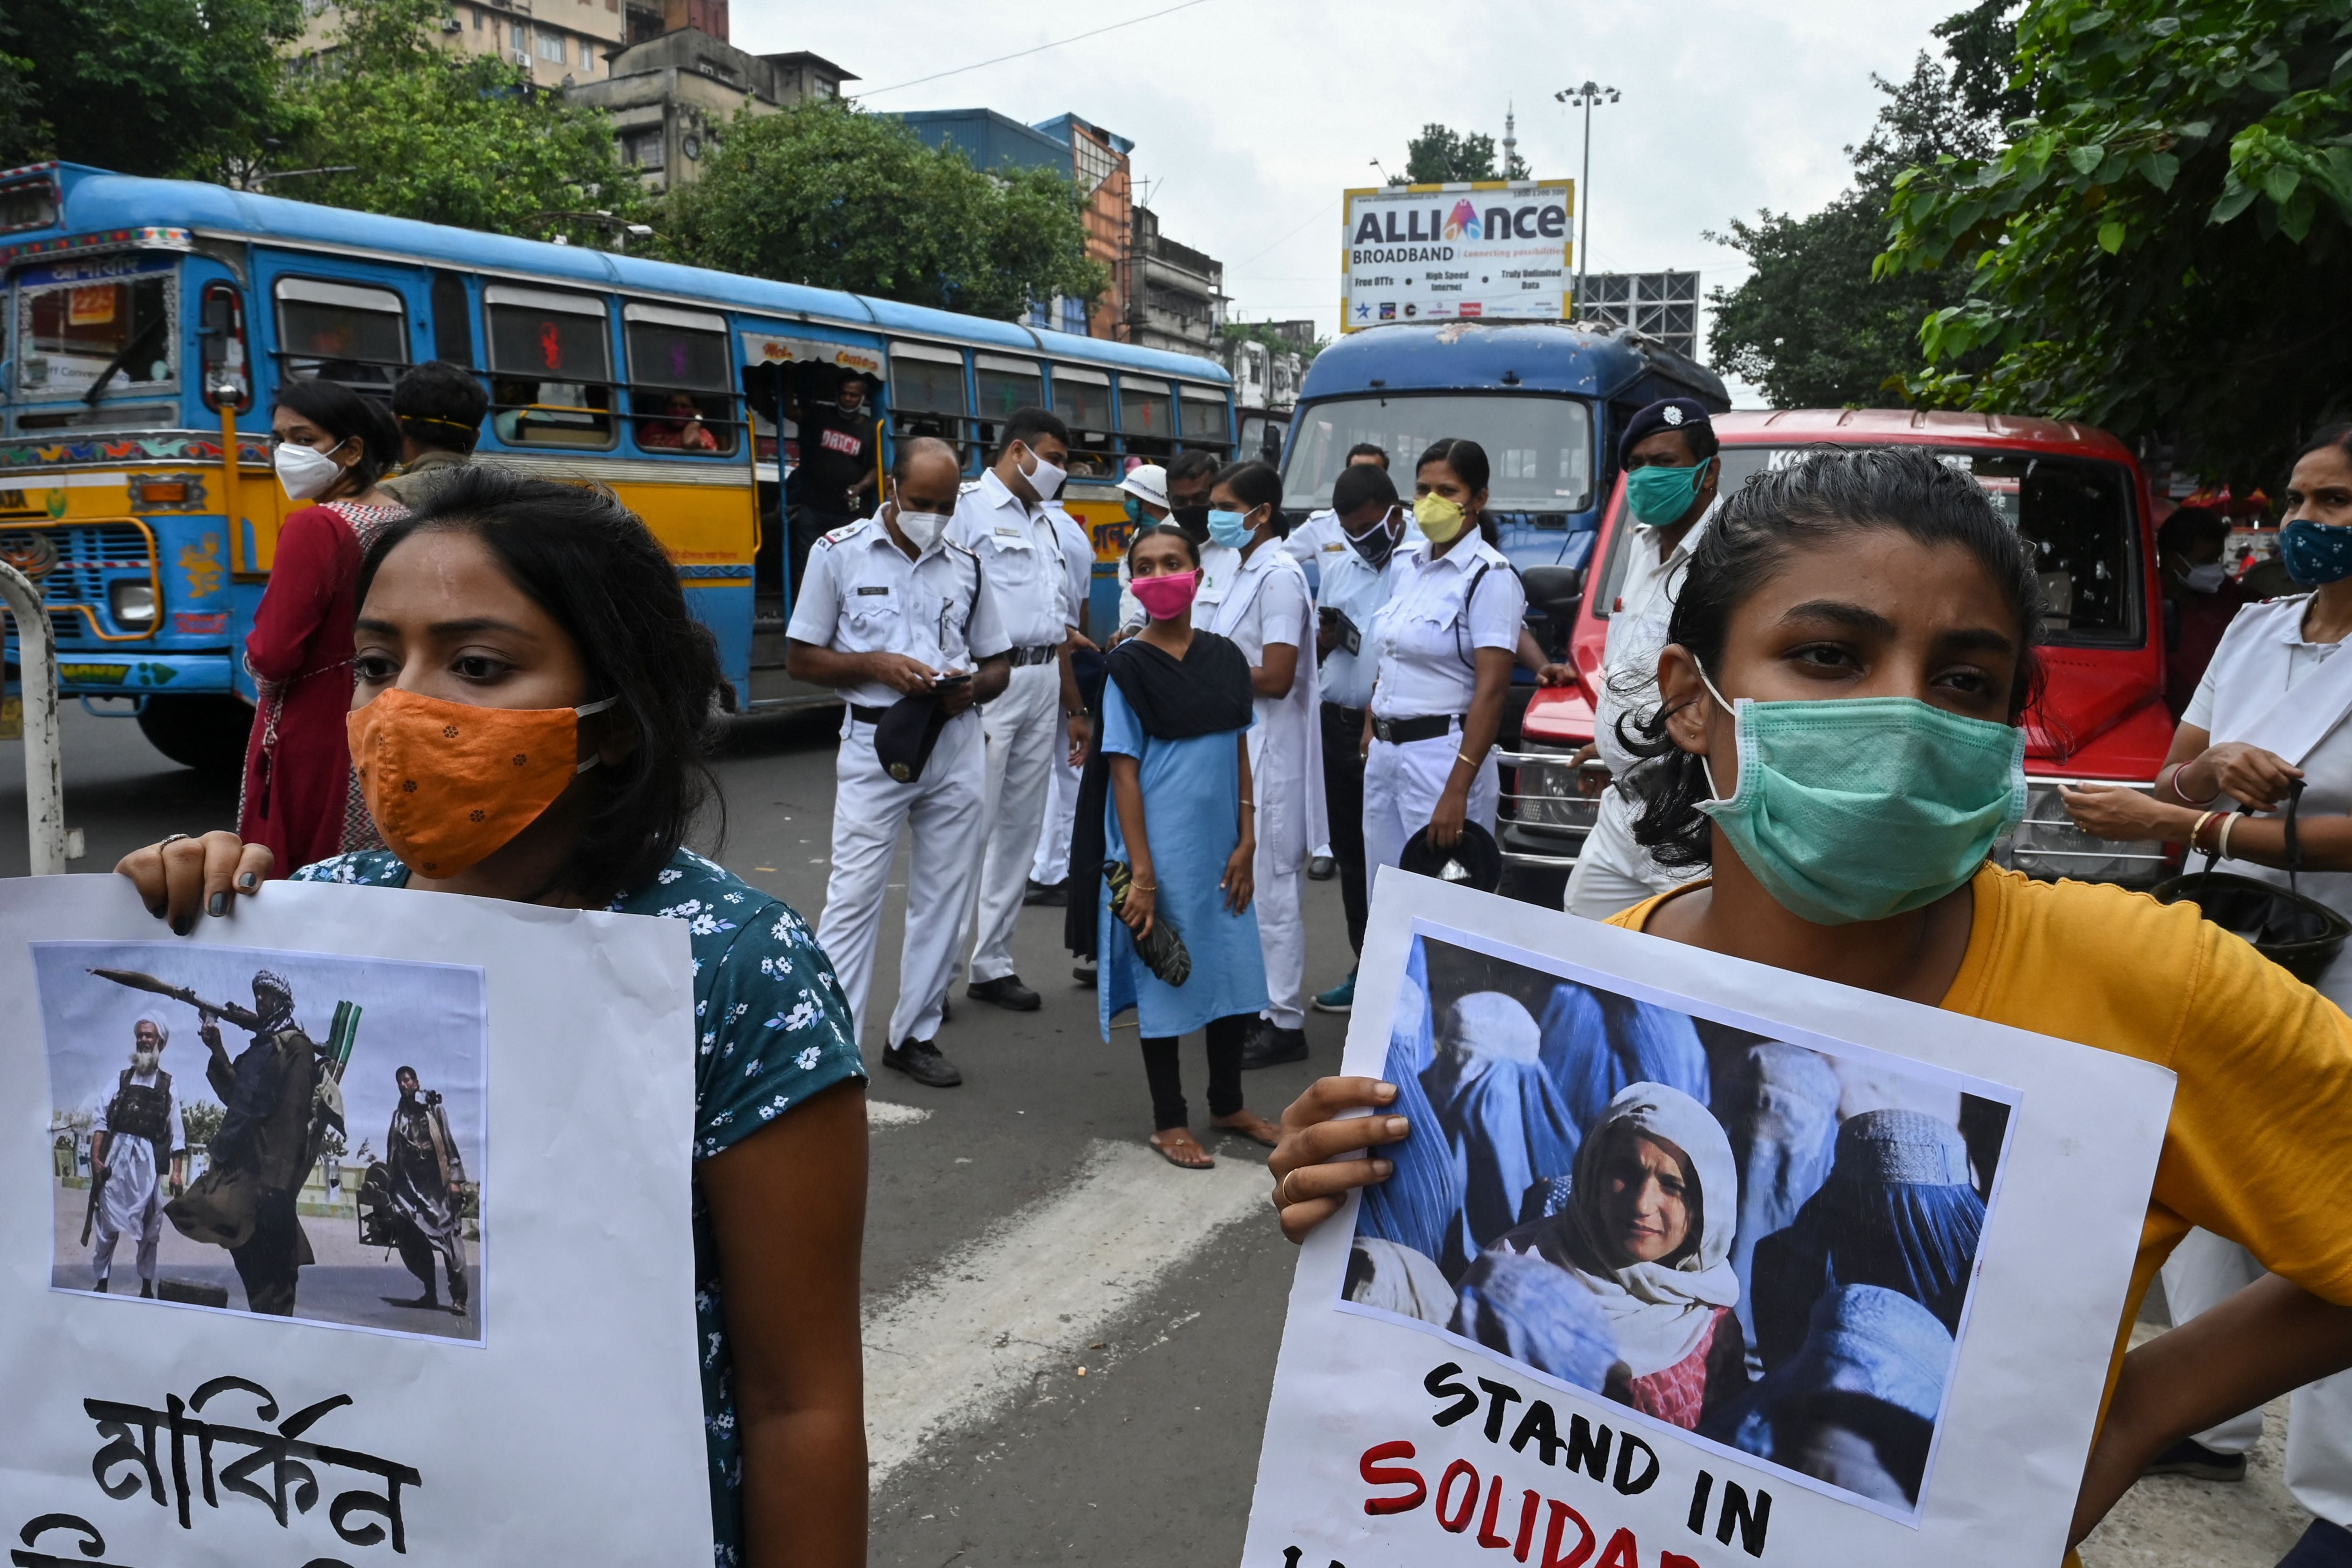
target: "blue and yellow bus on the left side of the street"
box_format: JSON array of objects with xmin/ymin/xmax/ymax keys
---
[{"xmin": 0, "ymin": 162, "xmax": 1235, "ymax": 769}]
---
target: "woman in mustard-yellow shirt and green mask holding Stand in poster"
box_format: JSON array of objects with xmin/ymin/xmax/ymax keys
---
[{"xmin": 1270, "ymin": 447, "xmax": 2352, "ymax": 1540}]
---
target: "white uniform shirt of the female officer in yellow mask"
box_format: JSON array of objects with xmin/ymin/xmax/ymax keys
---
[{"xmin": 1366, "ymin": 534, "xmax": 1526, "ymax": 719}]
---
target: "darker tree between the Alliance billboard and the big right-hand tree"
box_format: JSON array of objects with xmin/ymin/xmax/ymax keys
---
[{"xmin": 1708, "ymin": 49, "xmax": 1994, "ymax": 409}]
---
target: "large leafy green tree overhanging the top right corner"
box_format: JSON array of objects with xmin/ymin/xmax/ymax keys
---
[{"xmin": 1877, "ymin": 0, "xmax": 2352, "ymax": 480}]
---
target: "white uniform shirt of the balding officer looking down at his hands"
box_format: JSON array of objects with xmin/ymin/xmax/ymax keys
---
[{"xmin": 786, "ymin": 515, "xmax": 1011, "ymax": 708}]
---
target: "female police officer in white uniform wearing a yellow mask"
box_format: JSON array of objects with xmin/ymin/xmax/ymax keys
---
[{"xmin": 1364, "ymin": 437, "xmax": 1526, "ymax": 865}]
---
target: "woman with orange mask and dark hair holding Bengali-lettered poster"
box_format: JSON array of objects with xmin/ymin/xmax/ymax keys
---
[{"xmin": 115, "ymin": 468, "xmax": 866, "ymax": 1568}]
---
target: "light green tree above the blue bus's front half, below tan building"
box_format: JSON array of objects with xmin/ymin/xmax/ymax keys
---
[{"xmin": 268, "ymin": 0, "xmax": 647, "ymax": 249}]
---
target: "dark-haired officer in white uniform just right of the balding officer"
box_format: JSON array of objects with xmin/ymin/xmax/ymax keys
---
[{"xmin": 948, "ymin": 409, "xmax": 1094, "ymax": 1013}]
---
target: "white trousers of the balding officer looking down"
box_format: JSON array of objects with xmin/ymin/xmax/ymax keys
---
[{"xmin": 816, "ymin": 712, "xmax": 983, "ymax": 1044}]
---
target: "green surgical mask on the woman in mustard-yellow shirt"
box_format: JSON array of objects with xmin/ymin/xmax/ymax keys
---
[{"xmin": 1701, "ymin": 672, "xmax": 2025, "ymax": 926}]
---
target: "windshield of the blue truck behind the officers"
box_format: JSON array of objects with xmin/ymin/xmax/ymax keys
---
[{"xmin": 1282, "ymin": 393, "xmax": 1592, "ymax": 512}]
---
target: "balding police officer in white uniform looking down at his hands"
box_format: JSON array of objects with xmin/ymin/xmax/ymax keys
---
[{"xmin": 786, "ymin": 437, "xmax": 1011, "ymax": 1088}]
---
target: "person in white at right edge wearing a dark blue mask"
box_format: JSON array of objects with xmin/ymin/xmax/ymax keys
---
[{"xmin": 2065, "ymin": 426, "xmax": 2352, "ymax": 1568}]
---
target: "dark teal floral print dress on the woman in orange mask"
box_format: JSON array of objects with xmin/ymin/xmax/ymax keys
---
[{"xmin": 294, "ymin": 849, "xmax": 866, "ymax": 1568}]
